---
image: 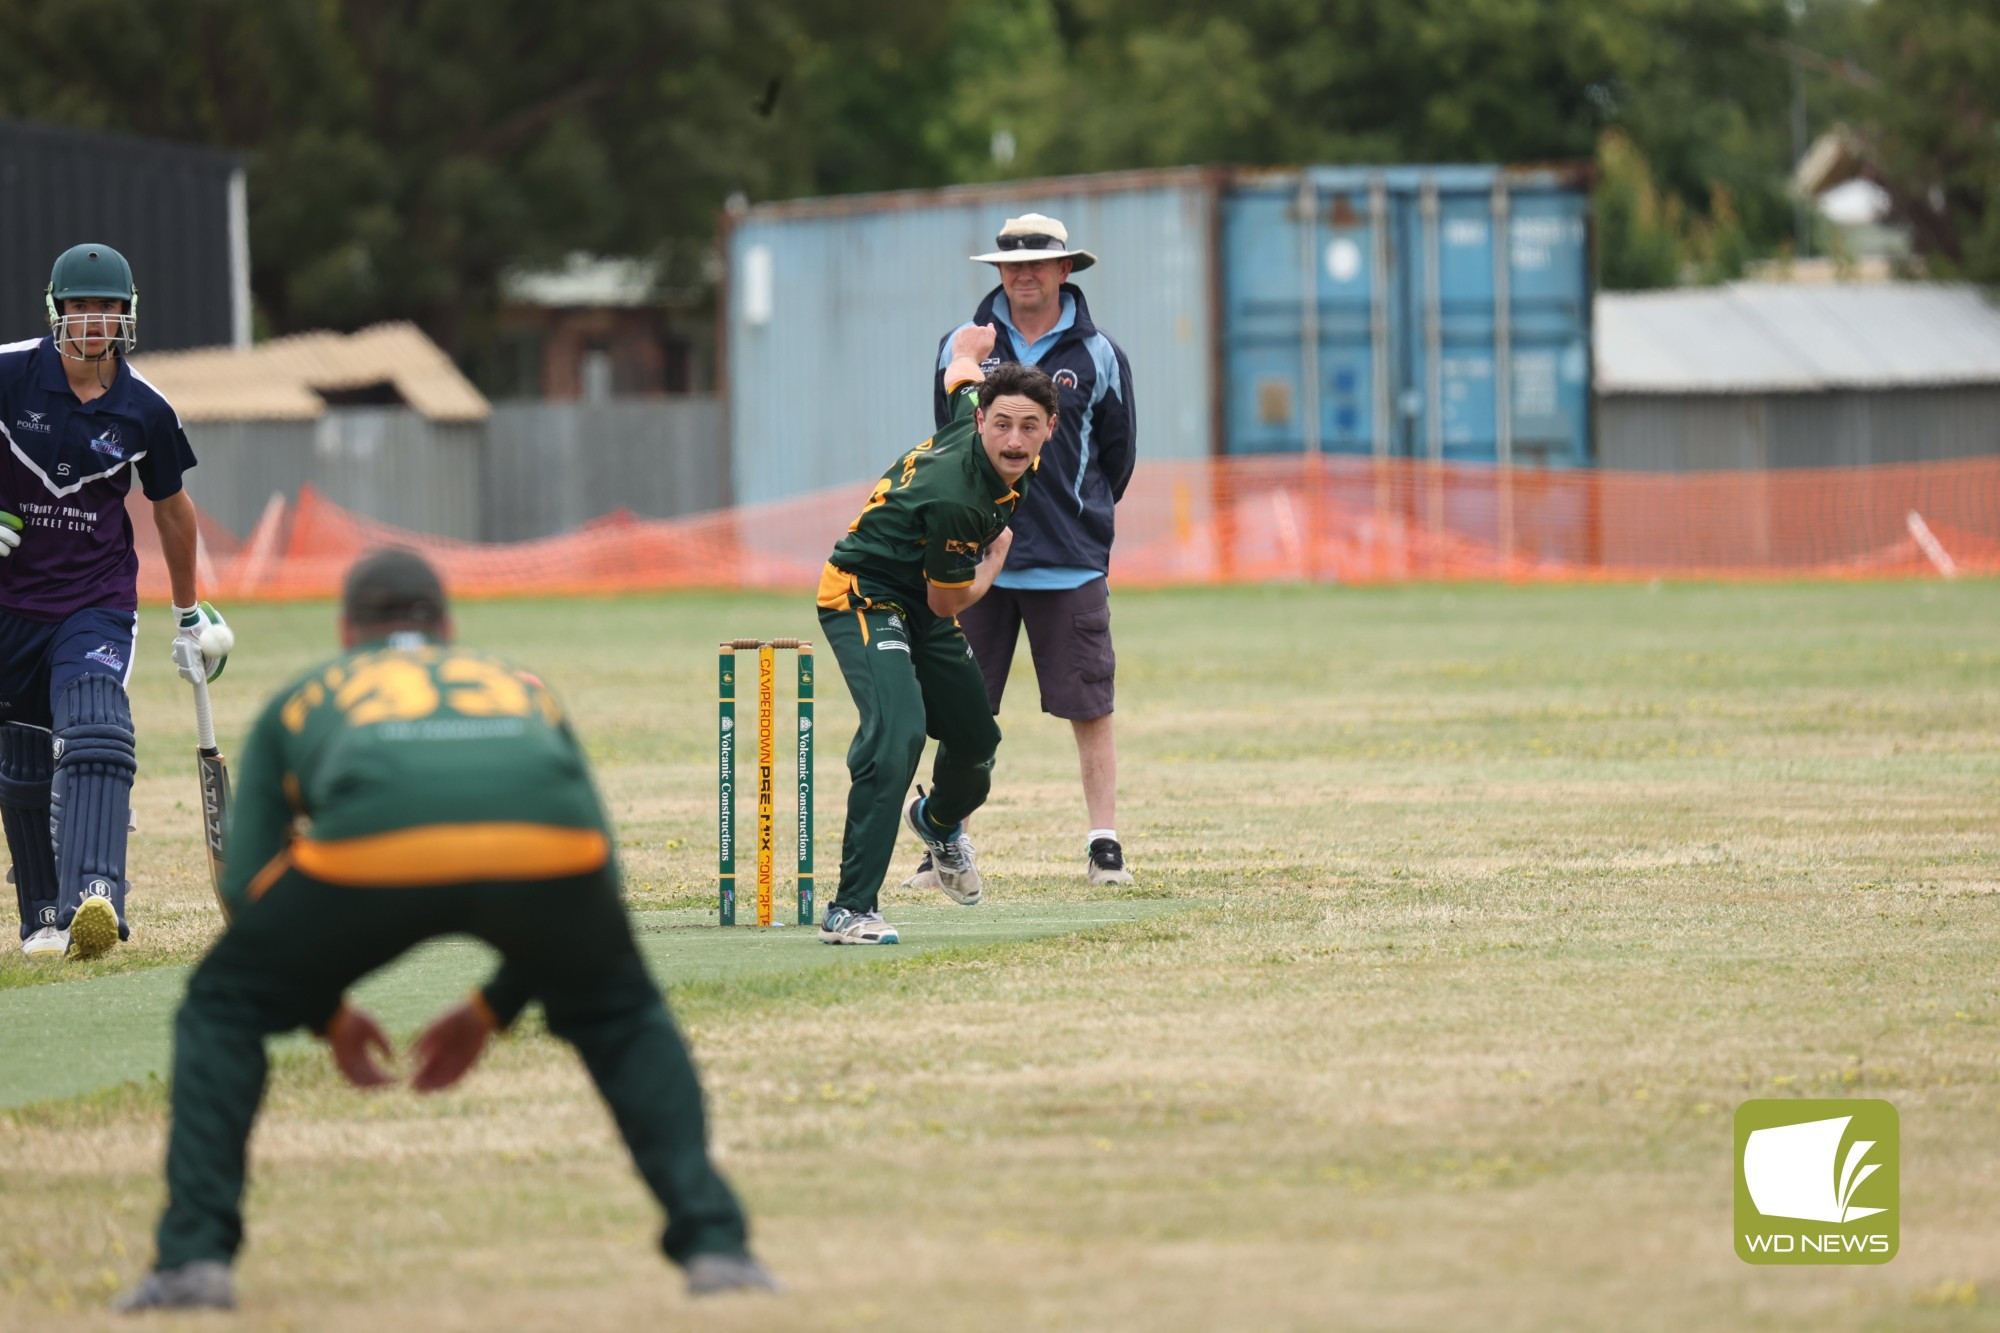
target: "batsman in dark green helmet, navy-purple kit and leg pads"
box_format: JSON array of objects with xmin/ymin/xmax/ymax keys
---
[{"xmin": 0, "ymin": 244, "xmax": 232, "ymax": 959}]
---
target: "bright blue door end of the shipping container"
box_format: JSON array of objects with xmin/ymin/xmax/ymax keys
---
[{"xmin": 1222, "ymin": 166, "xmax": 1592, "ymax": 466}]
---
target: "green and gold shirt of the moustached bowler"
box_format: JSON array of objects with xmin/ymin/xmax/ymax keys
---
[{"xmin": 820, "ymin": 382, "xmax": 1034, "ymax": 614}]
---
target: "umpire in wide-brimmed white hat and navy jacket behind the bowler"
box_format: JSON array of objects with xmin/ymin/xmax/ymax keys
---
[{"xmin": 910, "ymin": 212, "xmax": 1136, "ymax": 885}]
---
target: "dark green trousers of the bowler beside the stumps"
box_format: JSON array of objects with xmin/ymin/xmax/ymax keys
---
[{"xmin": 820, "ymin": 606, "xmax": 1000, "ymax": 913}]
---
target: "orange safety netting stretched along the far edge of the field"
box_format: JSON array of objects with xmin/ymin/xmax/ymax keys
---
[{"xmin": 132, "ymin": 454, "xmax": 2000, "ymax": 600}]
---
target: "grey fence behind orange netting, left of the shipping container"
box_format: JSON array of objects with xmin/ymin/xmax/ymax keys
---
[{"xmin": 188, "ymin": 396, "xmax": 730, "ymax": 542}]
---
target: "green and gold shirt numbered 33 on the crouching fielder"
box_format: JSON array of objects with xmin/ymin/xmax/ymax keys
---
[{"xmin": 222, "ymin": 634, "xmax": 610, "ymax": 911}]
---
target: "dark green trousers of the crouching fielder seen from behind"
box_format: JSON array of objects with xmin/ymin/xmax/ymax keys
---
[{"xmin": 158, "ymin": 869, "xmax": 746, "ymax": 1269}]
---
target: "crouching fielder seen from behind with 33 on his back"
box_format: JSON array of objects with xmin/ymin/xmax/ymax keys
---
[{"xmin": 118, "ymin": 550, "xmax": 776, "ymax": 1309}]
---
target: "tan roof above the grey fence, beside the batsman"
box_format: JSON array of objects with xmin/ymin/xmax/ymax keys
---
[{"xmin": 132, "ymin": 324, "xmax": 492, "ymax": 422}]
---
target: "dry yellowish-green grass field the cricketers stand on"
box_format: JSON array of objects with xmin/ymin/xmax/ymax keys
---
[{"xmin": 0, "ymin": 582, "xmax": 2000, "ymax": 1333}]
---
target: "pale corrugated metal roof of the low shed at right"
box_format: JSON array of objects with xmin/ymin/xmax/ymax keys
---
[{"xmin": 1596, "ymin": 282, "xmax": 2000, "ymax": 394}]
